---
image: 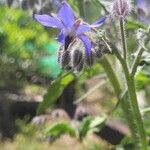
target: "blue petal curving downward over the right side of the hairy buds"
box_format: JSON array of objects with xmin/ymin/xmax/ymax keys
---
[{"xmin": 79, "ymin": 35, "xmax": 92, "ymax": 56}]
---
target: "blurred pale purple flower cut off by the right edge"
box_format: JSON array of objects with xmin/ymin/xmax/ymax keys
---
[{"xmin": 137, "ymin": 0, "xmax": 150, "ymax": 24}]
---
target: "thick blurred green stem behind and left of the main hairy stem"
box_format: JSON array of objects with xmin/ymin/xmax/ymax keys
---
[{"xmin": 101, "ymin": 57, "xmax": 137, "ymax": 143}]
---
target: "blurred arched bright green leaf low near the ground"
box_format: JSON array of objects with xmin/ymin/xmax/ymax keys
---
[{"xmin": 45, "ymin": 122, "xmax": 76, "ymax": 137}]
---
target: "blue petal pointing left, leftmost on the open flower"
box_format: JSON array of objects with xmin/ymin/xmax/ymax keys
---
[{"xmin": 34, "ymin": 14, "xmax": 63, "ymax": 29}]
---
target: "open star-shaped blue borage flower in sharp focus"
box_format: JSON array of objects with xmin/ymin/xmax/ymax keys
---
[{"xmin": 34, "ymin": 1, "xmax": 106, "ymax": 71}]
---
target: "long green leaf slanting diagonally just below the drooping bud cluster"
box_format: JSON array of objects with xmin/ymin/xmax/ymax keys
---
[{"xmin": 37, "ymin": 74, "xmax": 74, "ymax": 114}]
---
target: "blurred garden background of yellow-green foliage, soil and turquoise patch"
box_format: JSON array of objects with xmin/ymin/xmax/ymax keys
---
[{"xmin": 0, "ymin": 0, "xmax": 150, "ymax": 150}]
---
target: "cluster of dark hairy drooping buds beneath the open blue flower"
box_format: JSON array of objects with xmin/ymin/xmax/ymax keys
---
[{"xmin": 58, "ymin": 32, "xmax": 107, "ymax": 72}]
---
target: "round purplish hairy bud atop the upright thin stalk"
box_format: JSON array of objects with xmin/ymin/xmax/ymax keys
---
[{"xmin": 112, "ymin": 0, "xmax": 131, "ymax": 17}]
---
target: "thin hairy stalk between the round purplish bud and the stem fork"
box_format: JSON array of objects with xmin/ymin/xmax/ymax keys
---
[{"xmin": 120, "ymin": 18, "xmax": 127, "ymax": 61}]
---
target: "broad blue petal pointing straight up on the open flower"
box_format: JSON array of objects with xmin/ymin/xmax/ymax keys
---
[{"xmin": 58, "ymin": 1, "xmax": 75, "ymax": 28}]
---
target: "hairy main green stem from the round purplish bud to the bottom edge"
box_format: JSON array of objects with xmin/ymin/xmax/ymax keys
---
[{"xmin": 120, "ymin": 19, "xmax": 147, "ymax": 150}]
